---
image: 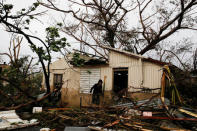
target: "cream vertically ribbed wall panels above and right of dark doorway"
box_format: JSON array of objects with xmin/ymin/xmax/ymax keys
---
[{"xmin": 109, "ymin": 51, "xmax": 162, "ymax": 92}]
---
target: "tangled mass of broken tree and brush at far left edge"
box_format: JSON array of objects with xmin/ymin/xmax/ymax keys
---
[{"xmin": 0, "ymin": 37, "xmax": 42, "ymax": 107}]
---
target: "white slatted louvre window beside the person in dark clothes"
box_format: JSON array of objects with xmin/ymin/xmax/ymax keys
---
[{"xmin": 80, "ymin": 68, "xmax": 101, "ymax": 93}]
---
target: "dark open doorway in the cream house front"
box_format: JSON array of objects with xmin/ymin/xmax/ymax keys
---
[{"xmin": 113, "ymin": 68, "xmax": 128, "ymax": 95}]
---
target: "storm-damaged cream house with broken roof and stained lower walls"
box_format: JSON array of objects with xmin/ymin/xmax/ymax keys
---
[{"xmin": 43, "ymin": 47, "xmax": 165, "ymax": 106}]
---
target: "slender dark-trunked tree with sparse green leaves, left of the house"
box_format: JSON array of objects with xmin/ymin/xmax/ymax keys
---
[{"xmin": 0, "ymin": 0, "xmax": 69, "ymax": 94}]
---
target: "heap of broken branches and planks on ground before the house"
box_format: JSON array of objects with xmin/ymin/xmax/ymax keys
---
[{"xmin": 31, "ymin": 98, "xmax": 197, "ymax": 130}]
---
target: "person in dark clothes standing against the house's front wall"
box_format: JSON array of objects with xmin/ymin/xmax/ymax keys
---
[{"xmin": 90, "ymin": 79, "xmax": 103, "ymax": 105}]
